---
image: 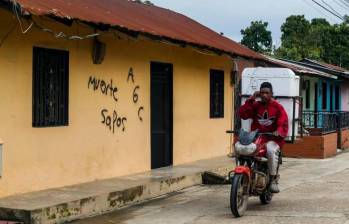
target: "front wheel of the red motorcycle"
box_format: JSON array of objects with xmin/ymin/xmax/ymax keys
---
[{"xmin": 230, "ymin": 174, "xmax": 249, "ymax": 218}]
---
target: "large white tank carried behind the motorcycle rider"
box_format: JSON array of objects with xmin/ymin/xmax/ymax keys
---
[{"xmin": 241, "ymin": 67, "xmax": 300, "ymax": 140}]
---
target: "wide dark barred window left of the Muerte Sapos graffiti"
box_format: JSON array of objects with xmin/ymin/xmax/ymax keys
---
[{"xmin": 33, "ymin": 47, "xmax": 69, "ymax": 127}]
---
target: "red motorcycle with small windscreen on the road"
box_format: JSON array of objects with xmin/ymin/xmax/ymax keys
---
[{"xmin": 229, "ymin": 130, "xmax": 282, "ymax": 217}]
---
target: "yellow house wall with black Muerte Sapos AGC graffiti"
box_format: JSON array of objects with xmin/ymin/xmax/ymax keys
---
[{"xmin": 0, "ymin": 9, "xmax": 232, "ymax": 197}]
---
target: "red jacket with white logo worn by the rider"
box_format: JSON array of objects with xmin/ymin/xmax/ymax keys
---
[{"xmin": 239, "ymin": 99, "xmax": 288, "ymax": 148}]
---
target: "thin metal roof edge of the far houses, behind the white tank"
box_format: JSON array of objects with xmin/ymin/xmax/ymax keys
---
[{"xmin": 265, "ymin": 56, "xmax": 337, "ymax": 79}]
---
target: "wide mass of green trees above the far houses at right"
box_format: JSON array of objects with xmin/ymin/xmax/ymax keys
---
[{"xmin": 274, "ymin": 15, "xmax": 349, "ymax": 68}]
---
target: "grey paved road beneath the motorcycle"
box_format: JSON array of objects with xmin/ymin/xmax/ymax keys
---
[{"xmin": 75, "ymin": 153, "xmax": 349, "ymax": 224}]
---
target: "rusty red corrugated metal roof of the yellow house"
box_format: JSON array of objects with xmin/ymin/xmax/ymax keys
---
[{"xmin": 1, "ymin": 0, "xmax": 263, "ymax": 59}]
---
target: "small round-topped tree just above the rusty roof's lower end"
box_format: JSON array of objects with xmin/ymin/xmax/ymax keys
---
[{"xmin": 241, "ymin": 21, "xmax": 272, "ymax": 53}]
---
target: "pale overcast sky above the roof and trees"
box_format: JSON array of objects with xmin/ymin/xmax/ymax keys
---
[{"xmin": 151, "ymin": 0, "xmax": 349, "ymax": 45}]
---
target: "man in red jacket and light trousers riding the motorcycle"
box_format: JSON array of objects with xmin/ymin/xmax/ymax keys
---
[{"xmin": 239, "ymin": 82, "xmax": 288, "ymax": 193}]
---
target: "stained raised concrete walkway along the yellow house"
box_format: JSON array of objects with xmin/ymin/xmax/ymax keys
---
[{"xmin": 0, "ymin": 156, "xmax": 235, "ymax": 224}]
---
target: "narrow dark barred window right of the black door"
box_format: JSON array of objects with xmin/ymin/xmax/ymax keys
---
[{"xmin": 210, "ymin": 70, "xmax": 224, "ymax": 118}]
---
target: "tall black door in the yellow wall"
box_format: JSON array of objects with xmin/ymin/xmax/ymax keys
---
[{"xmin": 151, "ymin": 62, "xmax": 173, "ymax": 169}]
